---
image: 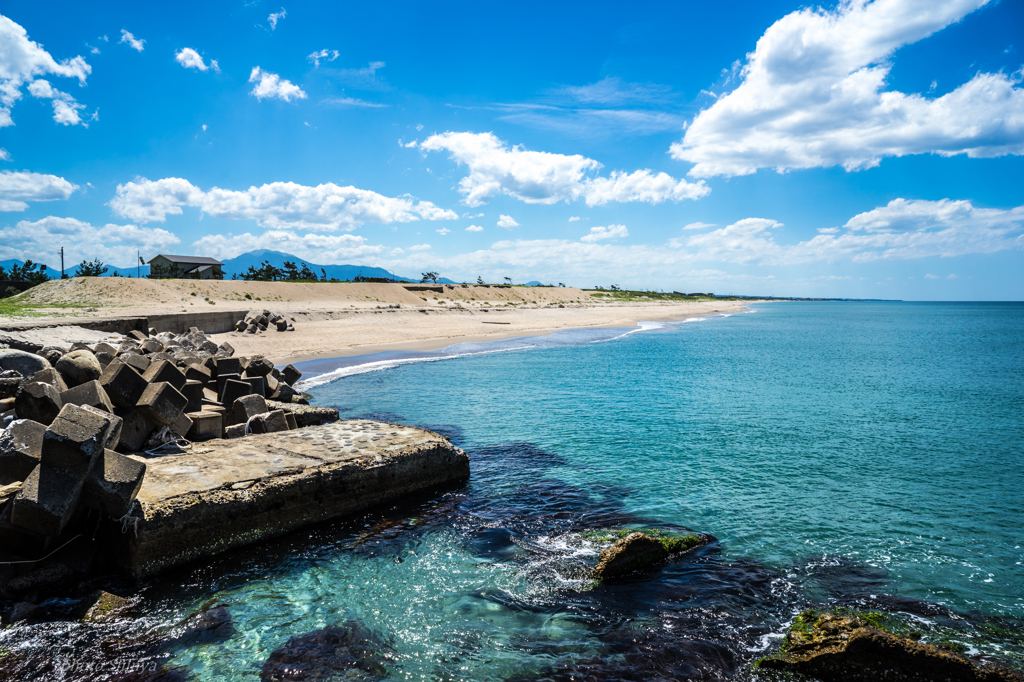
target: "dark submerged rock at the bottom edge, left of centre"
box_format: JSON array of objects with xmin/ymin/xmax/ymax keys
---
[{"xmin": 260, "ymin": 622, "xmax": 390, "ymax": 682}]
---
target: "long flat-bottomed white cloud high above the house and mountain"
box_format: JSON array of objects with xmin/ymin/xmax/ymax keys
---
[{"xmin": 110, "ymin": 177, "xmax": 459, "ymax": 230}]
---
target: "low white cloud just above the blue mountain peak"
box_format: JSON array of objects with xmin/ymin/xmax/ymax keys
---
[{"xmin": 193, "ymin": 229, "xmax": 384, "ymax": 263}]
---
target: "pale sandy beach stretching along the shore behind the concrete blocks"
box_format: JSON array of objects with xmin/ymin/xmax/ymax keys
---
[{"xmin": 0, "ymin": 278, "xmax": 745, "ymax": 365}]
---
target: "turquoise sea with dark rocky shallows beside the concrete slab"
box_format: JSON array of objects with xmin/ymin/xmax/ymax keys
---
[{"xmin": 0, "ymin": 301, "xmax": 1024, "ymax": 681}]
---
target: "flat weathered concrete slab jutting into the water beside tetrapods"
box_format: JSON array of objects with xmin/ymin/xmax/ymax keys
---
[{"xmin": 121, "ymin": 420, "xmax": 469, "ymax": 578}]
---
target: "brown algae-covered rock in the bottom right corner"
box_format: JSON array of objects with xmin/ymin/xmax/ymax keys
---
[{"xmin": 757, "ymin": 610, "xmax": 1024, "ymax": 682}]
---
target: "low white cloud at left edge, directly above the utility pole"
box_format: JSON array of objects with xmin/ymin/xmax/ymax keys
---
[{"xmin": 0, "ymin": 216, "xmax": 179, "ymax": 270}]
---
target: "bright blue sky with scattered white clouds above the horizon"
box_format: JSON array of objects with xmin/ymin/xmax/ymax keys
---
[{"xmin": 0, "ymin": 0, "xmax": 1024, "ymax": 300}]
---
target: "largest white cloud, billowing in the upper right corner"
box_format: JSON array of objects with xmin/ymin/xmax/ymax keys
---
[{"xmin": 671, "ymin": 0, "xmax": 1024, "ymax": 177}]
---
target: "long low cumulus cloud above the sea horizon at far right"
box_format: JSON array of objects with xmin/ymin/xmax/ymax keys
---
[{"xmin": 670, "ymin": 199, "xmax": 1024, "ymax": 265}]
